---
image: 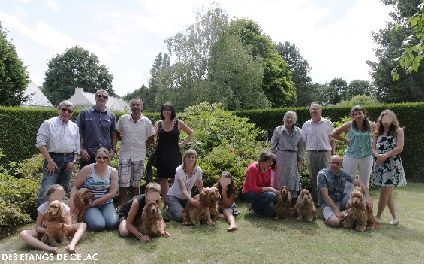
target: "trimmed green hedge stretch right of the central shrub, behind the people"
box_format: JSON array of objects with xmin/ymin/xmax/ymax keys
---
[{"xmin": 234, "ymin": 102, "xmax": 424, "ymax": 182}]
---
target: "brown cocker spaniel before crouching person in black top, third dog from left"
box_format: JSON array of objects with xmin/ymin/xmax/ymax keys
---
[{"xmin": 140, "ymin": 201, "xmax": 165, "ymax": 237}]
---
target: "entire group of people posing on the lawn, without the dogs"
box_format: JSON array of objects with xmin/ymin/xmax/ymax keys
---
[{"xmin": 20, "ymin": 90, "xmax": 406, "ymax": 252}]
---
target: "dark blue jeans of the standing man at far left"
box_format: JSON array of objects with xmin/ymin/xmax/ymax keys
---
[{"xmin": 38, "ymin": 155, "xmax": 74, "ymax": 205}]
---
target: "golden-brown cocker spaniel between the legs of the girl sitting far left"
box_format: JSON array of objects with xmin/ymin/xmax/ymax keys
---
[{"xmin": 41, "ymin": 200, "xmax": 66, "ymax": 247}]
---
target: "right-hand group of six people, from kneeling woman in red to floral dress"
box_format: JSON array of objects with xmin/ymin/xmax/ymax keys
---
[{"xmin": 242, "ymin": 103, "xmax": 406, "ymax": 226}]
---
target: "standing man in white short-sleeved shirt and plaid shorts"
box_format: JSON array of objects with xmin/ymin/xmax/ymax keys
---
[{"xmin": 116, "ymin": 98, "xmax": 155, "ymax": 211}]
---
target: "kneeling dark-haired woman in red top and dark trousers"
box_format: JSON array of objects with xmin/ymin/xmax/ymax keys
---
[{"xmin": 242, "ymin": 152, "xmax": 278, "ymax": 217}]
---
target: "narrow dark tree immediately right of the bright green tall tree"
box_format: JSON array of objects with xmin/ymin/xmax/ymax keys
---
[{"xmin": 277, "ymin": 41, "xmax": 316, "ymax": 106}]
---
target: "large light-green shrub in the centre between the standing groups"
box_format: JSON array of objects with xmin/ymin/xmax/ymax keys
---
[{"xmin": 181, "ymin": 103, "xmax": 269, "ymax": 187}]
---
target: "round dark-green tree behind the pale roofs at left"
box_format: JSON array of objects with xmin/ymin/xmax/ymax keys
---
[{"xmin": 43, "ymin": 46, "xmax": 114, "ymax": 105}]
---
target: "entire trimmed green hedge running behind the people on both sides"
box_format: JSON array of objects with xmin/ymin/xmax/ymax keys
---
[{"xmin": 0, "ymin": 103, "xmax": 424, "ymax": 182}]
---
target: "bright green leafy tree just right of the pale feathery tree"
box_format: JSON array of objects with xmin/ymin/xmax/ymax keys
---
[{"xmin": 229, "ymin": 19, "xmax": 296, "ymax": 107}]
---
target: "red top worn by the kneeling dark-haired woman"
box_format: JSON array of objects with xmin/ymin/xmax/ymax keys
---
[{"xmin": 242, "ymin": 161, "xmax": 271, "ymax": 193}]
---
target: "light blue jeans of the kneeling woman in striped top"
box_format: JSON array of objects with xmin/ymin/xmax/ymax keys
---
[{"xmin": 84, "ymin": 202, "xmax": 119, "ymax": 231}]
